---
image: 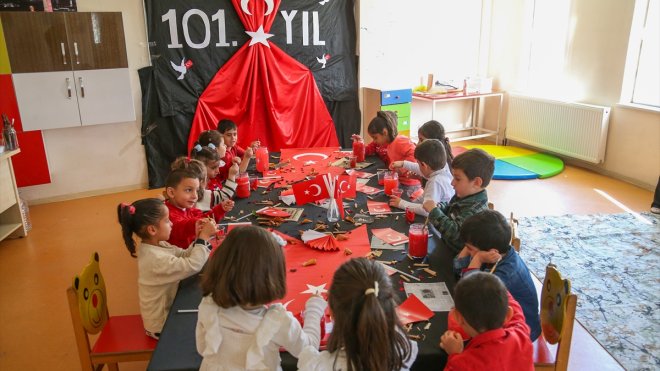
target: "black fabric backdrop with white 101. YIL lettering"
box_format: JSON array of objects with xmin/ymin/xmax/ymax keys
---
[{"xmin": 143, "ymin": 0, "xmax": 360, "ymax": 186}]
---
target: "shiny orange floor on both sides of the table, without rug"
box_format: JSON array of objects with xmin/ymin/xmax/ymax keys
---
[{"xmin": 0, "ymin": 161, "xmax": 653, "ymax": 371}]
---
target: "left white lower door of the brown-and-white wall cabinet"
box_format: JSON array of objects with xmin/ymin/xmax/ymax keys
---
[{"xmin": 12, "ymin": 71, "xmax": 81, "ymax": 131}]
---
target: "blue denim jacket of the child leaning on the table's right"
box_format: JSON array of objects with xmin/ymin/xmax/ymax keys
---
[{"xmin": 454, "ymin": 247, "xmax": 541, "ymax": 341}]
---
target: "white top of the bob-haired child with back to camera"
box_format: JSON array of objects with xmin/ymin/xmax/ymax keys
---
[{"xmin": 195, "ymin": 295, "xmax": 327, "ymax": 371}]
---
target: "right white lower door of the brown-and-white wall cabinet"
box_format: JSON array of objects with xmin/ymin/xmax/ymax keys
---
[{"xmin": 74, "ymin": 68, "xmax": 135, "ymax": 125}]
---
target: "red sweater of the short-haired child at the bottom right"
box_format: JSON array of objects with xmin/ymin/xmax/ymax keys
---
[{"xmin": 445, "ymin": 292, "xmax": 534, "ymax": 371}]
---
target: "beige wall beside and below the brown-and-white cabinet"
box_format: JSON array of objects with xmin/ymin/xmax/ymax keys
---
[{"xmin": 19, "ymin": 0, "xmax": 149, "ymax": 202}]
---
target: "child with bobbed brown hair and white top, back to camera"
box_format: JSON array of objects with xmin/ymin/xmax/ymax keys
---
[{"xmin": 195, "ymin": 226, "xmax": 327, "ymax": 370}]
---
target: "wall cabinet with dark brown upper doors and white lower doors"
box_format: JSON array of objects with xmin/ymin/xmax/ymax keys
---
[{"xmin": 0, "ymin": 12, "xmax": 135, "ymax": 131}]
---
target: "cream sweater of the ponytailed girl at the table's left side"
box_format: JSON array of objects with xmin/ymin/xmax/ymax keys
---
[{"xmin": 137, "ymin": 241, "xmax": 209, "ymax": 333}]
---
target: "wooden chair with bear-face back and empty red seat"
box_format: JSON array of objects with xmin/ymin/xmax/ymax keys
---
[{"xmin": 66, "ymin": 252, "xmax": 157, "ymax": 371}]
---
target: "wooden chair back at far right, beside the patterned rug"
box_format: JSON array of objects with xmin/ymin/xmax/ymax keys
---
[{"xmin": 534, "ymin": 264, "xmax": 577, "ymax": 371}]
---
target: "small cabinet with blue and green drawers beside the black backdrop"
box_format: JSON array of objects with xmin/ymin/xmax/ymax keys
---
[{"xmin": 362, "ymin": 88, "xmax": 412, "ymax": 142}]
